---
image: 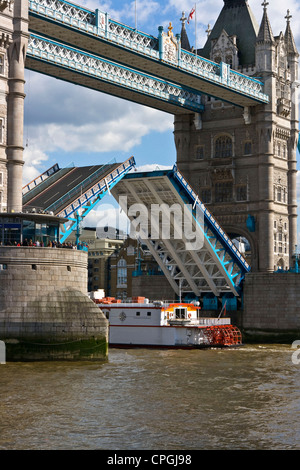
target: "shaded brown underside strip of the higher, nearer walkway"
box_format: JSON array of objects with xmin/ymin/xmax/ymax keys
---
[{"xmin": 26, "ymin": 11, "xmax": 261, "ymax": 107}]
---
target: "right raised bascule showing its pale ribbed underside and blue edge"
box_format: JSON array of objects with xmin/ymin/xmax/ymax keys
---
[{"xmin": 112, "ymin": 166, "xmax": 250, "ymax": 297}]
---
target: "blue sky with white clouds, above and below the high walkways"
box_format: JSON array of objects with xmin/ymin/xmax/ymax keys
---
[{"xmin": 24, "ymin": 0, "xmax": 300, "ymax": 231}]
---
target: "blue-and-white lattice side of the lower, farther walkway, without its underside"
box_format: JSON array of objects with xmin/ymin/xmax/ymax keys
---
[{"xmin": 26, "ymin": 34, "xmax": 204, "ymax": 113}]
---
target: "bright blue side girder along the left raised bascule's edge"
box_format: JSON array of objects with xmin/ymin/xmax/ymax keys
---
[{"xmin": 56, "ymin": 157, "xmax": 135, "ymax": 242}]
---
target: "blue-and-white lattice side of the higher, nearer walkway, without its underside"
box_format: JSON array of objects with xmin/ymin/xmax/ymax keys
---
[{"xmin": 29, "ymin": 0, "xmax": 269, "ymax": 105}]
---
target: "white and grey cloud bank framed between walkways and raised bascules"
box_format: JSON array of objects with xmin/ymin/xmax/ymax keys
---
[{"xmin": 25, "ymin": 72, "xmax": 173, "ymax": 167}]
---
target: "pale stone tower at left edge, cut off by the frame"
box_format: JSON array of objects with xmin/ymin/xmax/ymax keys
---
[{"xmin": 0, "ymin": 0, "xmax": 28, "ymax": 212}]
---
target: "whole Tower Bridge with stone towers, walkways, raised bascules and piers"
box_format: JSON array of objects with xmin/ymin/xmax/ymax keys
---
[{"xmin": 0, "ymin": 0, "xmax": 300, "ymax": 360}]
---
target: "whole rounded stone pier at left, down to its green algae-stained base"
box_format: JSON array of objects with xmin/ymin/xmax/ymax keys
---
[{"xmin": 0, "ymin": 247, "xmax": 108, "ymax": 361}]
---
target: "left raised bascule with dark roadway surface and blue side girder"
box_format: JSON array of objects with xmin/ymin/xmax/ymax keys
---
[{"xmin": 23, "ymin": 157, "xmax": 135, "ymax": 242}]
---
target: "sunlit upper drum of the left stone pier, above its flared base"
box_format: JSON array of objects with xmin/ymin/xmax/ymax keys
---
[{"xmin": 0, "ymin": 247, "xmax": 88, "ymax": 311}]
